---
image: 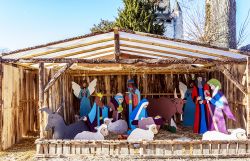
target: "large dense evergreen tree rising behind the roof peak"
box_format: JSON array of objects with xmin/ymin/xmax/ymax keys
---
[{"xmin": 116, "ymin": 0, "xmax": 164, "ymax": 35}]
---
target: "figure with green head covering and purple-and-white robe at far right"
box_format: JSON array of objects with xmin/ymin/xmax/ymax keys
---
[{"xmin": 206, "ymin": 79, "xmax": 235, "ymax": 134}]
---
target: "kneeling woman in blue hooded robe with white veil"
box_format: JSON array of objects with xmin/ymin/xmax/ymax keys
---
[{"xmin": 128, "ymin": 98, "xmax": 148, "ymax": 133}]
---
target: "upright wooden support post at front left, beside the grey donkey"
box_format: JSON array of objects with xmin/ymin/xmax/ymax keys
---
[{"xmin": 38, "ymin": 63, "xmax": 45, "ymax": 138}]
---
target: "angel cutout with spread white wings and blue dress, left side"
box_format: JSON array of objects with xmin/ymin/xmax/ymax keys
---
[{"xmin": 72, "ymin": 79, "xmax": 97, "ymax": 117}]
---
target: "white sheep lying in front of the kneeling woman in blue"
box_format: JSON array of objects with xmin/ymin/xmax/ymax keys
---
[{"xmin": 127, "ymin": 124, "xmax": 158, "ymax": 141}]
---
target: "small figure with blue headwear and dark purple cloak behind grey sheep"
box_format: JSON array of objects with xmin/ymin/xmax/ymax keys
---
[{"xmin": 108, "ymin": 93, "xmax": 124, "ymax": 121}]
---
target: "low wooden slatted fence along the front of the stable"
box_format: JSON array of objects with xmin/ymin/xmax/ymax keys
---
[{"xmin": 35, "ymin": 139, "xmax": 250, "ymax": 159}]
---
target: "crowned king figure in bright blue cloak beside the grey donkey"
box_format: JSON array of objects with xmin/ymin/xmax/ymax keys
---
[{"xmin": 83, "ymin": 93, "xmax": 109, "ymax": 132}]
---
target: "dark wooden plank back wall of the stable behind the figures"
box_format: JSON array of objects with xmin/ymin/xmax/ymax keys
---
[{"xmin": 48, "ymin": 65, "xmax": 246, "ymax": 128}]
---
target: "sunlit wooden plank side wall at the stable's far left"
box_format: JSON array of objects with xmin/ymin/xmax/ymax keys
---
[{"xmin": 0, "ymin": 65, "xmax": 38, "ymax": 149}]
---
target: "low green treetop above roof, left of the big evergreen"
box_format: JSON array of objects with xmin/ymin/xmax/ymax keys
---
[{"xmin": 90, "ymin": 19, "xmax": 115, "ymax": 33}]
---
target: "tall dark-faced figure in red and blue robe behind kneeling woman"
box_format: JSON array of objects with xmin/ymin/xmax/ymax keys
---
[{"xmin": 125, "ymin": 79, "xmax": 141, "ymax": 128}]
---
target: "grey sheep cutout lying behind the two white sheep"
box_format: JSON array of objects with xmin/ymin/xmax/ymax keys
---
[{"xmin": 104, "ymin": 118, "xmax": 128, "ymax": 134}]
